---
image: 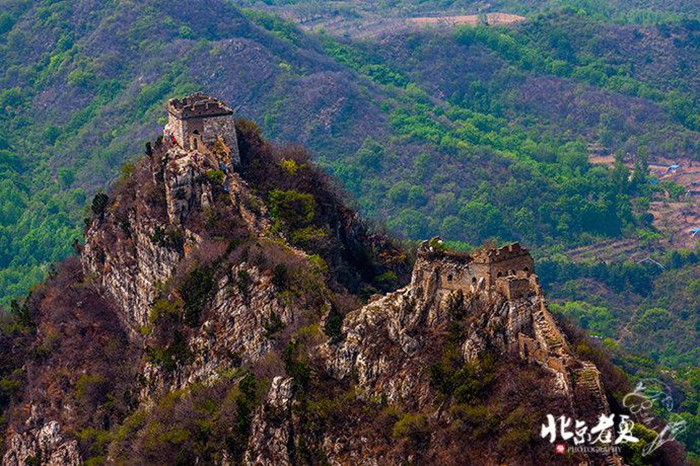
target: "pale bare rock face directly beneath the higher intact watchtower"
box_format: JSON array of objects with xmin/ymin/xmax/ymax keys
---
[{"xmin": 81, "ymin": 147, "xmax": 270, "ymax": 331}]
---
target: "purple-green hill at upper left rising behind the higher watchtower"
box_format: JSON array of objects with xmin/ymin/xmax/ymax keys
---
[{"xmin": 0, "ymin": 1, "xmax": 379, "ymax": 303}]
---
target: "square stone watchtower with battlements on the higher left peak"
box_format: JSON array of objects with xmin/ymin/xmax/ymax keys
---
[{"xmin": 164, "ymin": 92, "xmax": 240, "ymax": 166}]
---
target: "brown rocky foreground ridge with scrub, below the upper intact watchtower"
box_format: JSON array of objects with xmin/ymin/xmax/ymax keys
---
[{"xmin": 3, "ymin": 116, "xmax": 617, "ymax": 465}]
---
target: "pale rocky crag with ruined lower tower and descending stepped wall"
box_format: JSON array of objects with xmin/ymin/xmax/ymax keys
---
[{"xmin": 324, "ymin": 238, "xmax": 619, "ymax": 464}]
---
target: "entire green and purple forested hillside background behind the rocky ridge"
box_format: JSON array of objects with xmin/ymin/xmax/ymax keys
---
[{"xmin": 0, "ymin": 0, "xmax": 700, "ymax": 453}]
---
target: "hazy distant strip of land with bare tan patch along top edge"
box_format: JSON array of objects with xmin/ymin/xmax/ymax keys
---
[{"xmin": 239, "ymin": 0, "xmax": 700, "ymax": 38}]
